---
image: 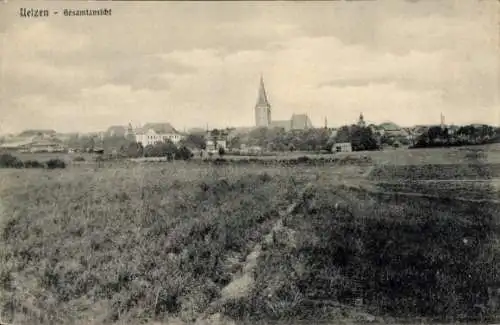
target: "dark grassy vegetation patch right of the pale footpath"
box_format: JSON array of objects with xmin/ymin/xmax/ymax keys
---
[{"xmin": 239, "ymin": 182, "xmax": 499, "ymax": 321}]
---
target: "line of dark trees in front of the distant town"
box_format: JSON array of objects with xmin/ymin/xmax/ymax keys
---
[{"xmin": 60, "ymin": 125, "xmax": 500, "ymax": 159}]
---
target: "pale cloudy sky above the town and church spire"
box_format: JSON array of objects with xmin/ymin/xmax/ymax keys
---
[{"xmin": 0, "ymin": 0, "xmax": 500, "ymax": 133}]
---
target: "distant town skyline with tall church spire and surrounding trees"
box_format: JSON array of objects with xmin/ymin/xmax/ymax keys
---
[{"xmin": 0, "ymin": 77, "xmax": 500, "ymax": 156}]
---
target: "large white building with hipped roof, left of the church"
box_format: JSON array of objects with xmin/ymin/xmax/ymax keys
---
[{"xmin": 135, "ymin": 123, "xmax": 183, "ymax": 147}]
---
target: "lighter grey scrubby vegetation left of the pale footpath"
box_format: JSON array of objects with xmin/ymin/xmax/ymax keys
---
[{"xmin": 0, "ymin": 167, "xmax": 302, "ymax": 324}]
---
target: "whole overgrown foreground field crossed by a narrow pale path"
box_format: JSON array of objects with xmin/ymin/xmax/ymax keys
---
[{"xmin": 0, "ymin": 163, "xmax": 500, "ymax": 324}]
